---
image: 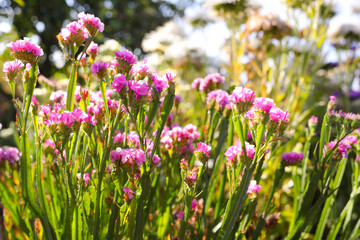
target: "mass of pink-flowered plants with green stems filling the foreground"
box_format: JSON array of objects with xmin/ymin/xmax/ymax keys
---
[{"xmin": 0, "ymin": 10, "xmax": 360, "ymax": 239}]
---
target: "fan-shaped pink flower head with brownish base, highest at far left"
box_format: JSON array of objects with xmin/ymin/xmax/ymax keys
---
[{"xmin": 8, "ymin": 38, "xmax": 44, "ymax": 64}]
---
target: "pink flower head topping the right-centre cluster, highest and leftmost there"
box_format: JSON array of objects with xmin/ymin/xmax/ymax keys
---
[{"xmin": 229, "ymin": 87, "xmax": 255, "ymax": 113}]
